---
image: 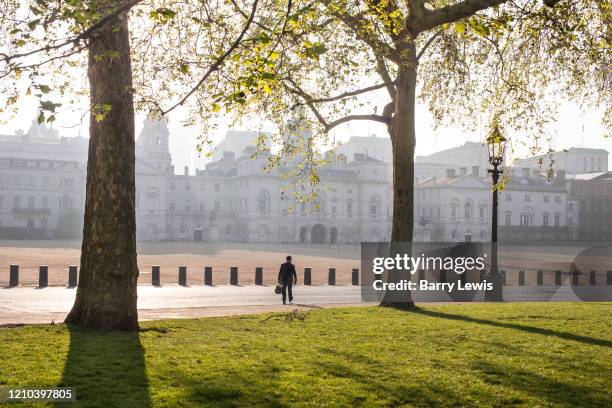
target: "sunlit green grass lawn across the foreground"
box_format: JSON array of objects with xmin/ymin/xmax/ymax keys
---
[{"xmin": 0, "ymin": 303, "xmax": 612, "ymax": 407}]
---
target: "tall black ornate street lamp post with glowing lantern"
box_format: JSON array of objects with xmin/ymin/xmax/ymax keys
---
[{"xmin": 485, "ymin": 125, "xmax": 506, "ymax": 302}]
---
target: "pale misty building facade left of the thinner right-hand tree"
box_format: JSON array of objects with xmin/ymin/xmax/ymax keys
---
[{"xmin": 0, "ymin": 116, "xmax": 391, "ymax": 244}]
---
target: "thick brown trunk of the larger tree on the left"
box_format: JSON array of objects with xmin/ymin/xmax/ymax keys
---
[{"xmin": 66, "ymin": 0, "xmax": 138, "ymax": 330}]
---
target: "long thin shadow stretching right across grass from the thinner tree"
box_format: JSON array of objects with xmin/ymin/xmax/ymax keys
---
[{"xmin": 411, "ymin": 309, "xmax": 612, "ymax": 347}]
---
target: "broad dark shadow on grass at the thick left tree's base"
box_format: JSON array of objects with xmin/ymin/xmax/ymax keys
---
[{"xmin": 58, "ymin": 326, "xmax": 151, "ymax": 408}]
